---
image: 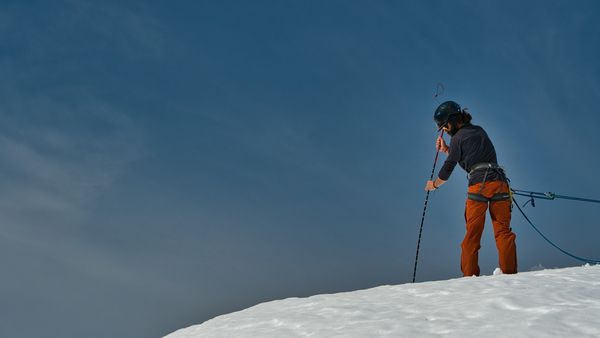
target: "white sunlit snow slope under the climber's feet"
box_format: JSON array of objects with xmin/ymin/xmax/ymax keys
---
[{"xmin": 165, "ymin": 265, "xmax": 600, "ymax": 338}]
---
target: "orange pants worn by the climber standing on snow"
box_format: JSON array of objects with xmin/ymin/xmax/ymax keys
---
[{"xmin": 460, "ymin": 181, "xmax": 517, "ymax": 276}]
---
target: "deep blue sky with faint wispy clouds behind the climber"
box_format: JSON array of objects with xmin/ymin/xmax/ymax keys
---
[{"xmin": 0, "ymin": 0, "xmax": 600, "ymax": 338}]
